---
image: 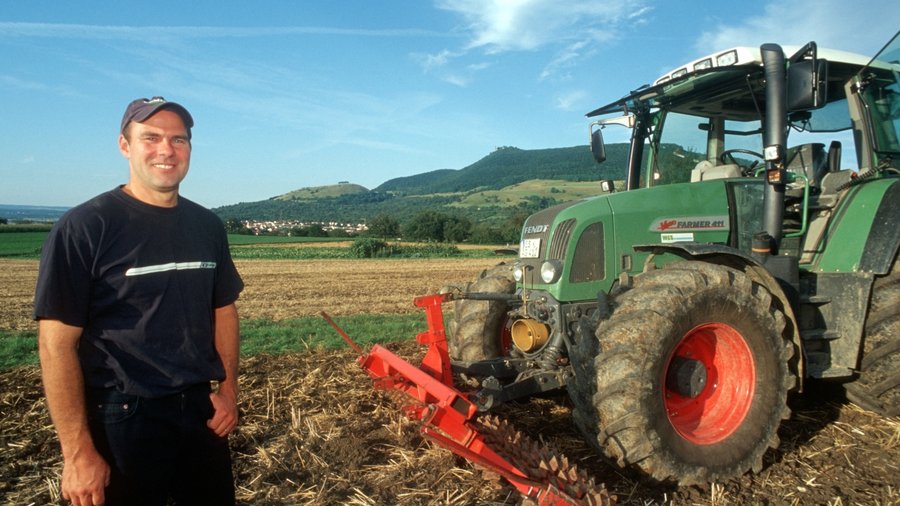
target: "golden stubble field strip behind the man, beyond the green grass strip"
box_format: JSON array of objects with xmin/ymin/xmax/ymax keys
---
[{"xmin": 0, "ymin": 258, "xmax": 498, "ymax": 330}]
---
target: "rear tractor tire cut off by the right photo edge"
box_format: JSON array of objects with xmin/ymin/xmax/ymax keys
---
[{"xmin": 845, "ymin": 262, "xmax": 900, "ymax": 416}]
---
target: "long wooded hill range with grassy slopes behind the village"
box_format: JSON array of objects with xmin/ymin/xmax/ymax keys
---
[{"xmin": 214, "ymin": 144, "xmax": 628, "ymax": 223}]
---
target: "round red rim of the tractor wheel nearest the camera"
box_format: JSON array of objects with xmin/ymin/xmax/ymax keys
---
[{"xmin": 662, "ymin": 323, "xmax": 756, "ymax": 445}]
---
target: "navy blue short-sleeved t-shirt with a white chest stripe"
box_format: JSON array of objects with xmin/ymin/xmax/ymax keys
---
[{"xmin": 34, "ymin": 187, "xmax": 244, "ymax": 397}]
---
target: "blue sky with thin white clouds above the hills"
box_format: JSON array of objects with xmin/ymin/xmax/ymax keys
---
[{"xmin": 0, "ymin": 0, "xmax": 900, "ymax": 207}]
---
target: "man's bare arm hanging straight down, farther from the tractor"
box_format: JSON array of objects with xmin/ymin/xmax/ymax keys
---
[{"xmin": 38, "ymin": 320, "xmax": 109, "ymax": 505}]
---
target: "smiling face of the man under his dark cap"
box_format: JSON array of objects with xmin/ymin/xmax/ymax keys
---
[{"xmin": 119, "ymin": 110, "xmax": 191, "ymax": 203}]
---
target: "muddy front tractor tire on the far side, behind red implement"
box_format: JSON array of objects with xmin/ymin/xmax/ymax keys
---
[{"xmin": 447, "ymin": 263, "xmax": 516, "ymax": 362}]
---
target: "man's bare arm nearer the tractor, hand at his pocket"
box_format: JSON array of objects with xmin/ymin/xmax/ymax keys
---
[{"xmin": 207, "ymin": 303, "xmax": 240, "ymax": 437}]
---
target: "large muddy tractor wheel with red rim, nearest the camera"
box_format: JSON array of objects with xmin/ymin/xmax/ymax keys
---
[{"xmin": 573, "ymin": 261, "xmax": 796, "ymax": 485}]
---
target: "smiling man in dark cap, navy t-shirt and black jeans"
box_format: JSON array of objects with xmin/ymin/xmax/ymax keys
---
[{"xmin": 34, "ymin": 97, "xmax": 243, "ymax": 506}]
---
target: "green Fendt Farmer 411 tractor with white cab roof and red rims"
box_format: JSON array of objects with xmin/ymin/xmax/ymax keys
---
[{"xmin": 448, "ymin": 30, "xmax": 900, "ymax": 484}]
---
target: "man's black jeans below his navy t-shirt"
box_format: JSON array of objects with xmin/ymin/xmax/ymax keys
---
[{"xmin": 87, "ymin": 385, "xmax": 234, "ymax": 506}]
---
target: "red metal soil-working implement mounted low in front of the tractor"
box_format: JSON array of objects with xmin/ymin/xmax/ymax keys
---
[{"xmin": 322, "ymin": 295, "xmax": 615, "ymax": 506}]
